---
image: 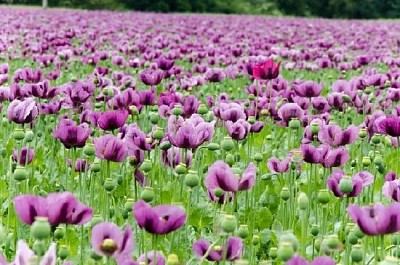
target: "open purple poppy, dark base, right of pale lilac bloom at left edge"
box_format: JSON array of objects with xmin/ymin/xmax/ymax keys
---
[{"xmin": 53, "ymin": 119, "xmax": 91, "ymax": 149}]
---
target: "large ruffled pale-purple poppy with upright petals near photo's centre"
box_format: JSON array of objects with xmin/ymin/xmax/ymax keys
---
[{"xmin": 167, "ymin": 114, "xmax": 215, "ymax": 149}]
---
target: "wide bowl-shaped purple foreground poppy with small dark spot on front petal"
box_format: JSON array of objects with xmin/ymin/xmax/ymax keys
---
[{"xmin": 133, "ymin": 200, "xmax": 186, "ymax": 235}]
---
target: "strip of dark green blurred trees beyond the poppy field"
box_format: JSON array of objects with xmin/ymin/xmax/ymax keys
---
[{"xmin": 0, "ymin": 0, "xmax": 400, "ymax": 18}]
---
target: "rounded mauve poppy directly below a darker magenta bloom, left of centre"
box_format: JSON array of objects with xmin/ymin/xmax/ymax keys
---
[{"xmin": 93, "ymin": 134, "xmax": 128, "ymax": 162}]
